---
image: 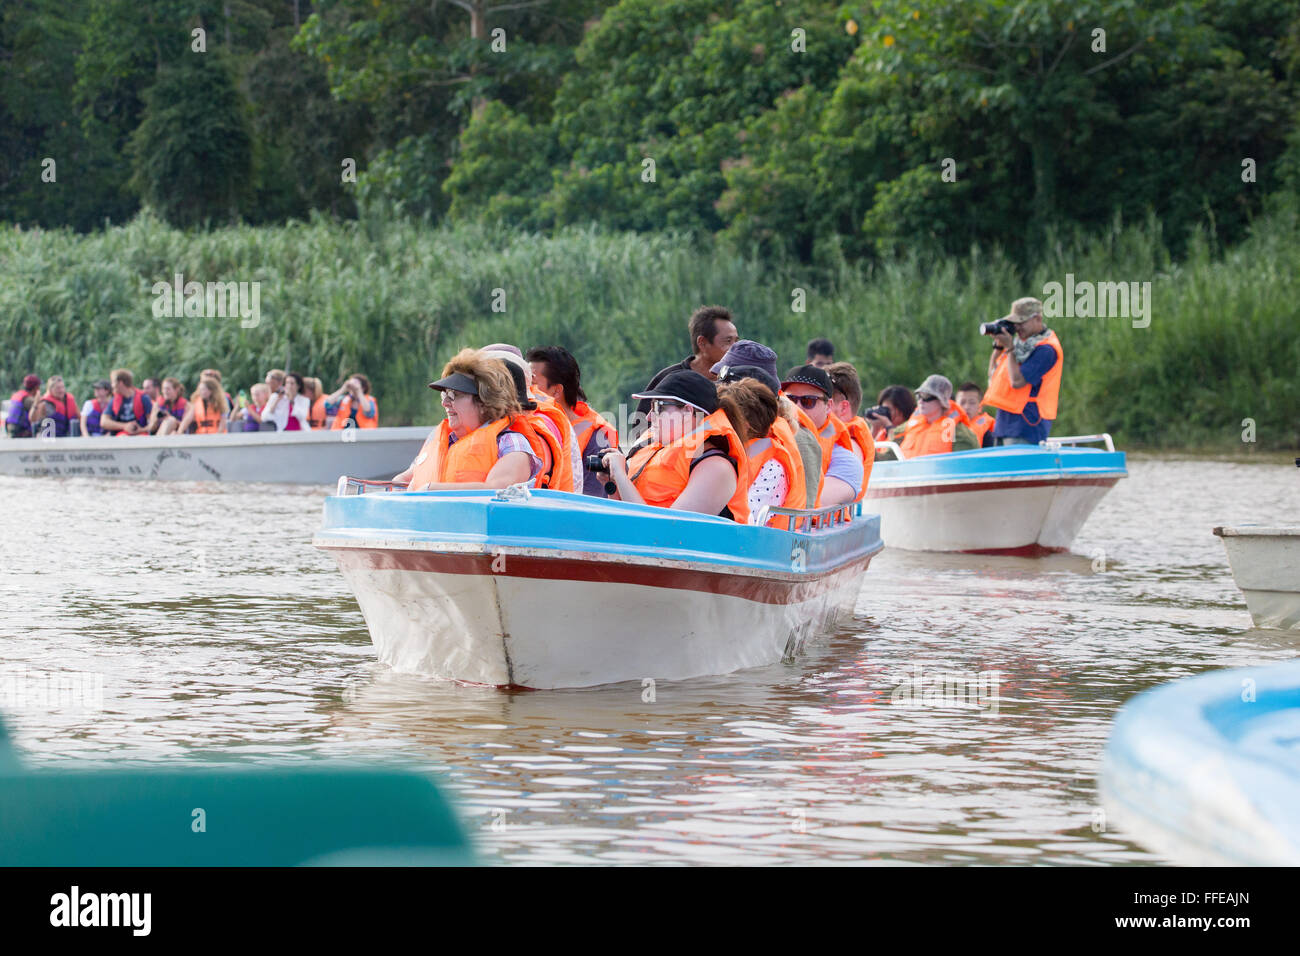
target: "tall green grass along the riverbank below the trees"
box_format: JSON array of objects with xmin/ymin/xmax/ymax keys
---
[{"xmin": 0, "ymin": 211, "xmax": 1300, "ymax": 449}]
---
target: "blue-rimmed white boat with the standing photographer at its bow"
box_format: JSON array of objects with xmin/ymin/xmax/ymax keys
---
[{"xmin": 863, "ymin": 434, "xmax": 1128, "ymax": 555}]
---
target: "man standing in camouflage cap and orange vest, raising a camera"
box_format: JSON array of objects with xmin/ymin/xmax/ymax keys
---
[{"xmin": 979, "ymin": 298, "xmax": 1065, "ymax": 445}]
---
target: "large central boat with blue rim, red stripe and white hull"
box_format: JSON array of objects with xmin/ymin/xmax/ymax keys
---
[{"xmin": 313, "ymin": 481, "xmax": 881, "ymax": 688}]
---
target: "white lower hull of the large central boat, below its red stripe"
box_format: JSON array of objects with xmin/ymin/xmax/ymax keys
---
[{"xmin": 335, "ymin": 550, "xmax": 866, "ymax": 688}]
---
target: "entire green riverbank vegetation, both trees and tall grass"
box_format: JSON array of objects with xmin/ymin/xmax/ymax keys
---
[{"xmin": 0, "ymin": 0, "xmax": 1300, "ymax": 447}]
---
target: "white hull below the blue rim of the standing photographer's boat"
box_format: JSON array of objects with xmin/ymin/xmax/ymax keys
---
[{"xmin": 863, "ymin": 479, "xmax": 1114, "ymax": 554}]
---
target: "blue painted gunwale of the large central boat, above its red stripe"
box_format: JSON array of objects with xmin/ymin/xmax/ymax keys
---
[{"xmin": 315, "ymin": 490, "xmax": 884, "ymax": 576}]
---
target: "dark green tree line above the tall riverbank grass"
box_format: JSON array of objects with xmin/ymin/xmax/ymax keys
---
[{"xmin": 0, "ymin": 0, "xmax": 1300, "ymax": 264}]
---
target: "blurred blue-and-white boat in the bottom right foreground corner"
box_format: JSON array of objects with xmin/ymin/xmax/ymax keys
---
[{"xmin": 1101, "ymin": 661, "xmax": 1300, "ymax": 866}]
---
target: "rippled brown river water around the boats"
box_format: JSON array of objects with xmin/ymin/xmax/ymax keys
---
[{"xmin": 0, "ymin": 458, "xmax": 1300, "ymax": 864}]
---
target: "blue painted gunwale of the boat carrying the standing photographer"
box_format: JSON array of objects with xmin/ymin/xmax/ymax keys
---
[{"xmin": 867, "ymin": 445, "xmax": 1128, "ymax": 486}]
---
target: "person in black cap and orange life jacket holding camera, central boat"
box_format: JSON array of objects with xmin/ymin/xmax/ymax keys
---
[{"xmin": 605, "ymin": 371, "xmax": 749, "ymax": 524}]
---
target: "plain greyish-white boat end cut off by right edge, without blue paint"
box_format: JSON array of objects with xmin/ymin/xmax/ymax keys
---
[{"xmin": 1214, "ymin": 524, "xmax": 1300, "ymax": 630}]
